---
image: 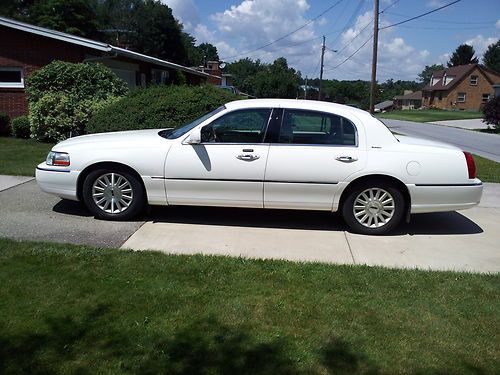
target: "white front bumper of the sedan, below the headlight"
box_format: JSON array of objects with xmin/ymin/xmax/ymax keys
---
[{"xmin": 35, "ymin": 163, "xmax": 80, "ymax": 201}]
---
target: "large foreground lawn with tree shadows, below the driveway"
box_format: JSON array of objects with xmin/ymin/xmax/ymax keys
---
[{"xmin": 0, "ymin": 239, "xmax": 500, "ymax": 375}]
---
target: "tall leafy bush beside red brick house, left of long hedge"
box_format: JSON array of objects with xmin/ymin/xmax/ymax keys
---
[{"xmin": 26, "ymin": 61, "xmax": 128, "ymax": 142}]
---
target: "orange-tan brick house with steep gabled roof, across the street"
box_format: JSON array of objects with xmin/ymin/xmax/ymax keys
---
[{"xmin": 422, "ymin": 64, "xmax": 500, "ymax": 111}]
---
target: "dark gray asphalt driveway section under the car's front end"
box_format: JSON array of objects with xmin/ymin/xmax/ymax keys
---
[{"xmin": 0, "ymin": 180, "xmax": 143, "ymax": 247}]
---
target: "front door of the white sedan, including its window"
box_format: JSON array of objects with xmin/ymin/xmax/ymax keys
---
[{"xmin": 165, "ymin": 108, "xmax": 272, "ymax": 207}]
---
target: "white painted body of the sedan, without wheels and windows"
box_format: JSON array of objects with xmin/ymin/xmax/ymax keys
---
[{"xmin": 36, "ymin": 99, "xmax": 483, "ymax": 235}]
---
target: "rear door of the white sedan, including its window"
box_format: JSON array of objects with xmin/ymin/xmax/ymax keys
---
[{"xmin": 264, "ymin": 109, "xmax": 366, "ymax": 210}]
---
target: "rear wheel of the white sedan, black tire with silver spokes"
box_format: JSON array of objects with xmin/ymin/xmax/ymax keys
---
[{"xmin": 342, "ymin": 180, "xmax": 405, "ymax": 235}]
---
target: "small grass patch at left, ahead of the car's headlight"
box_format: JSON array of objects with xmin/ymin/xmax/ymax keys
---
[{"xmin": 0, "ymin": 137, "xmax": 53, "ymax": 176}]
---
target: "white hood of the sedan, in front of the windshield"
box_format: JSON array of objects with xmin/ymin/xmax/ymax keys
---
[{"xmin": 53, "ymin": 129, "xmax": 168, "ymax": 151}]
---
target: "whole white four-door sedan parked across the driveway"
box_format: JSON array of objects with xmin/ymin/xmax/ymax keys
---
[{"xmin": 36, "ymin": 99, "xmax": 483, "ymax": 234}]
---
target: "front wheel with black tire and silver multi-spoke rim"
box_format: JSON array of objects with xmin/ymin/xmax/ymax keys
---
[{"xmin": 82, "ymin": 167, "xmax": 146, "ymax": 220}]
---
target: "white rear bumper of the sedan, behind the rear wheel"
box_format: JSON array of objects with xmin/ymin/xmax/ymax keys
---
[{"xmin": 407, "ymin": 179, "xmax": 483, "ymax": 214}]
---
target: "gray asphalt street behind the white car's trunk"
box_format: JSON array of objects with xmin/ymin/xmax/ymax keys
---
[{"xmin": 383, "ymin": 119, "xmax": 500, "ymax": 163}]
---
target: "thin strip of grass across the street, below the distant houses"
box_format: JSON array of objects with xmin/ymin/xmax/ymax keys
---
[{"xmin": 376, "ymin": 109, "xmax": 483, "ymax": 122}]
